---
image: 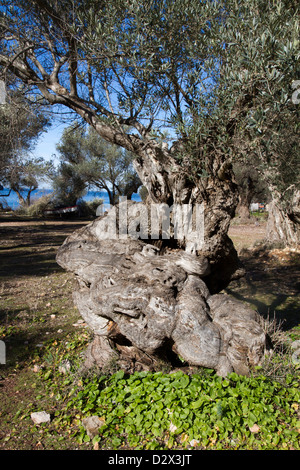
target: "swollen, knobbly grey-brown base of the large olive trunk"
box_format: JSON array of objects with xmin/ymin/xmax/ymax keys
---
[{"xmin": 57, "ymin": 202, "xmax": 265, "ymax": 376}]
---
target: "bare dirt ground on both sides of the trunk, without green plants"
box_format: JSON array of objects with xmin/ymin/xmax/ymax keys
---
[{"xmin": 0, "ymin": 217, "xmax": 300, "ymax": 449}]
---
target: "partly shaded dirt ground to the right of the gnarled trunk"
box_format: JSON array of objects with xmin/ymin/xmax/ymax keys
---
[{"xmin": 226, "ymin": 221, "xmax": 300, "ymax": 331}]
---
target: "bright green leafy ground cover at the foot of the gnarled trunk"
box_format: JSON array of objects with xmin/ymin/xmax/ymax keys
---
[{"xmin": 38, "ymin": 346, "xmax": 300, "ymax": 450}]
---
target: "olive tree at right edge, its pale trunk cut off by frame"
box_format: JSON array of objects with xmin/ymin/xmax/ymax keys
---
[{"xmin": 220, "ymin": 0, "xmax": 300, "ymax": 242}]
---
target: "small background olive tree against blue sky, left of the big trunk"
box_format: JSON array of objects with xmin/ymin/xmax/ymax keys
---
[{"xmin": 57, "ymin": 123, "xmax": 141, "ymax": 205}]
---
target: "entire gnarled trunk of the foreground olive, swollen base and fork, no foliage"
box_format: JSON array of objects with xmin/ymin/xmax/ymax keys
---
[{"xmin": 57, "ymin": 142, "xmax": 265, "ymax": 375}]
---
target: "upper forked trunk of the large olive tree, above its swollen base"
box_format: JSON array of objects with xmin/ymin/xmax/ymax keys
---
[{"xmin": 133, "ymin": 142, "xmax": 243, "ymax": 293}]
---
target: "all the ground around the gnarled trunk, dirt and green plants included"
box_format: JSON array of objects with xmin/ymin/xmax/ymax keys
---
[{"xmin": 0, "ymin": 217, "xmax": 300, "ymax": 450}]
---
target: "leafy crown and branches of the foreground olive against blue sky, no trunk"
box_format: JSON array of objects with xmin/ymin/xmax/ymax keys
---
[{"xmin": 0, "ymin": 0, "xmax": 299, "ymax": 174}]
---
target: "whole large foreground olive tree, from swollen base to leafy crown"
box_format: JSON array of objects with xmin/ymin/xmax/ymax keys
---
[{"xmin": 0, "ymin": 0, "xmax": 297, "ymax": 374}]
